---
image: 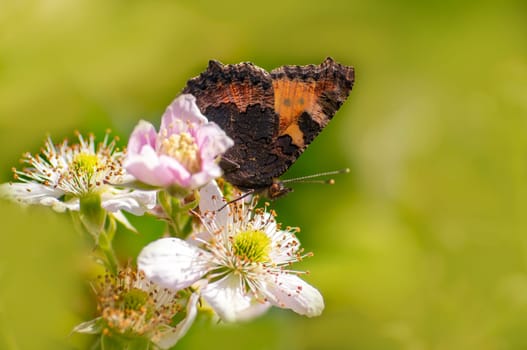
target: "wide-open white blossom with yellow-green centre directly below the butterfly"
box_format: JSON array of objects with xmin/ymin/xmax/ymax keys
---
[{"xmin": 138, "ymin": 182, "xmax": 324, "ymax": 321}]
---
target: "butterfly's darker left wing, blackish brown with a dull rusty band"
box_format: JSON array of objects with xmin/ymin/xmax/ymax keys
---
[{"xmin": 183, "ymin": 61, "xmax": 293, "ymax": 190}]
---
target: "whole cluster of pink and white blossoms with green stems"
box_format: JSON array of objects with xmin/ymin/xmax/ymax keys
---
[{"xmin": 0, "ymin": 95, "xmax": 324, "ymax": 349}]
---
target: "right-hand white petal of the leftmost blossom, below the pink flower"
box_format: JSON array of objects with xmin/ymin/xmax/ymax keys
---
[{"xmin": 101, "ymin": 190, "xmax": 156, "ymax": 215}]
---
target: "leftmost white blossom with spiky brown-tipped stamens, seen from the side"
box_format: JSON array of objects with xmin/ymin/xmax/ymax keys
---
[{"xmin": 0, "ymin": 133, "xmax": 156, "ymax": 226}]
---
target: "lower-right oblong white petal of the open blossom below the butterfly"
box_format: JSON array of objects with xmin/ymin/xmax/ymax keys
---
[{"xmin": 262, "ymin": 273, "xmax": 324, "ymax": 317}]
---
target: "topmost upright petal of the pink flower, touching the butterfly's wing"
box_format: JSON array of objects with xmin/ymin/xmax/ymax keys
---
[{"xmin": 160, "ymin": 94, "xmax": 207, "ymax": 135}]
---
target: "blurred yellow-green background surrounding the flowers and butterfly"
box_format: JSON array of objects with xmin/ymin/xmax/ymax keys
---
[{"xmin": 0, "ymin": 0, "xmax": 527, "ymax": 350}]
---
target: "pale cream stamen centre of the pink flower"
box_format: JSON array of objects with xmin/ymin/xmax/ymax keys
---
[{"xmin": 160, "ymin": 132, "xmax": 201, "ymax": 173}]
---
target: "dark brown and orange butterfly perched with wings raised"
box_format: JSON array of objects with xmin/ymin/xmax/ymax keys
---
[{"xmin": 182, "ymin": 57, "xmax": 355, "ymax": 199}]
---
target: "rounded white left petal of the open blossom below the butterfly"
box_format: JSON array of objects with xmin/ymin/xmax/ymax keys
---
[{"xmin": 137, "ymin": 238, "xmax": 210, "ymax": 290}]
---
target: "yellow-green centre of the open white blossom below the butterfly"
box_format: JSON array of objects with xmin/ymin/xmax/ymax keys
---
[{"xmin": 232, "ymin": 230, "xmax": 271, "ymax": 262}]
